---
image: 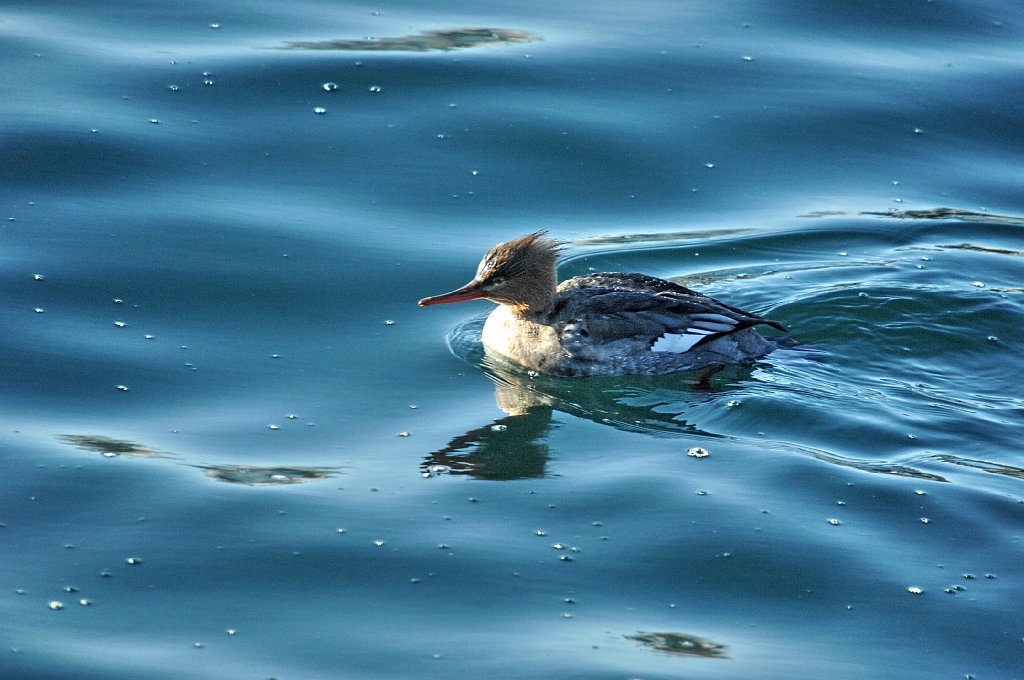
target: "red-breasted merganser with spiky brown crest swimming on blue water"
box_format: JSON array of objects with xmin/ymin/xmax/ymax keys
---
[{"xmin": 420, "ymin": 230, "xmax": 785, "ymax": 376}]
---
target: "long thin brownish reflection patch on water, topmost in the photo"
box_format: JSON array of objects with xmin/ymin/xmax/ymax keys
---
[{"xmin": 278, "ymin": 28, "xmax": 542, "ymax": 52}]
